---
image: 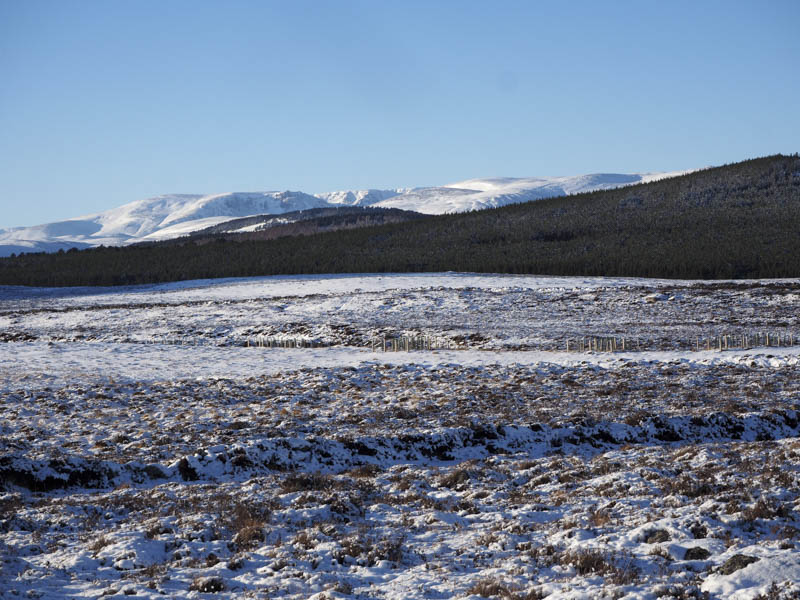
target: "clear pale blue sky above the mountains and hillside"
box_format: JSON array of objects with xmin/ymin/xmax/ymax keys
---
[{"xmin": 0, "ymin": 0, "xmax": 800, "ymax": 227}]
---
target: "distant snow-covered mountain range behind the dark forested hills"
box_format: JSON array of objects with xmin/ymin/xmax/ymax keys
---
[{"xmin": 0, "ymin": 171, "xmax": 686, "ymax": 256}]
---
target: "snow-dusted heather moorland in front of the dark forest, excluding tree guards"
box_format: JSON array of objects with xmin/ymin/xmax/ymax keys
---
[{"xmin": 0, "ymin": 273, "xmax": 800, "ymax": 600}]
